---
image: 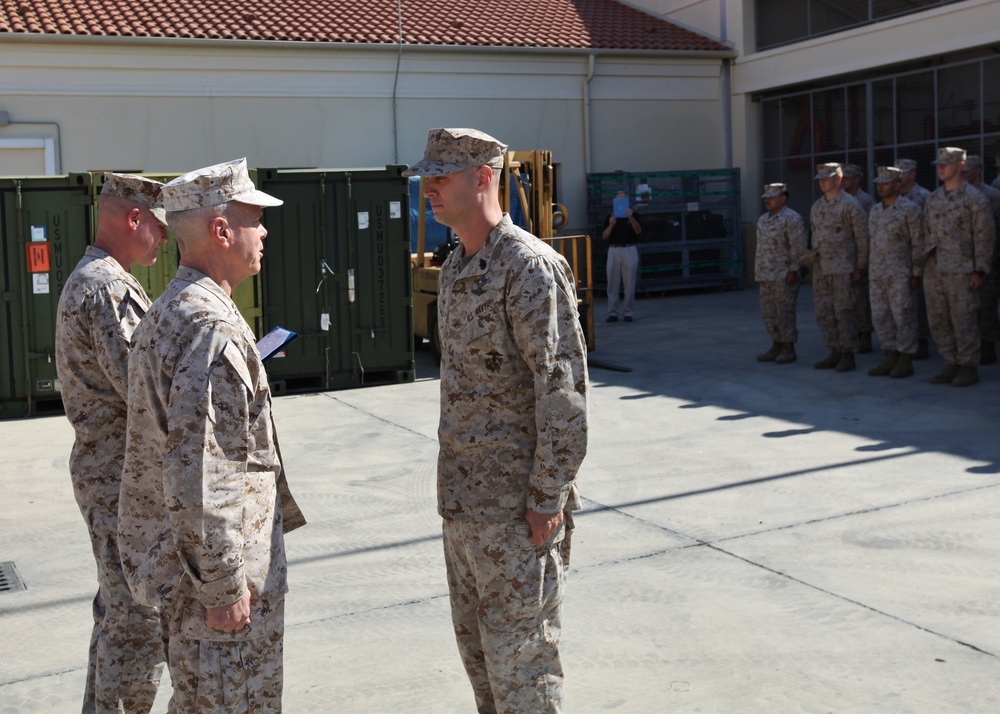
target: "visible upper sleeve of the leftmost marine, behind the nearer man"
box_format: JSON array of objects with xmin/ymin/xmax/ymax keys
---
[{"xmin": 86, "ymin": 283, "xmax": 146, "ymax": 402}]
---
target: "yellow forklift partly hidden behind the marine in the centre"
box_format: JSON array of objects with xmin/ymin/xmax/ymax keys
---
[{"xmin": 412, "ymin": 150, "xmax": 596, "ymax": 356}]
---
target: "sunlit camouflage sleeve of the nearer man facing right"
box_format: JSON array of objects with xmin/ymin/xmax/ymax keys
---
[{"xmin": 163, "ymin": 326, "xmax": 252, "ymax": 608}]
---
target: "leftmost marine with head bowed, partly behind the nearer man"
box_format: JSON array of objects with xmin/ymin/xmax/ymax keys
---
[{"xmin": 56, "ymin": 173, "xmax": 166, "ymax": 714}]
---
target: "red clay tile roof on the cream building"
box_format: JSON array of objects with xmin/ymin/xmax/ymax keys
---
[{"xmin": 0, "ymin": 0, "xmax": 726, "ymax": 51}]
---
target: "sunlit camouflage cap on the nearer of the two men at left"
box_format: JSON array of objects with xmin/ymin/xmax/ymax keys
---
[{"xmin": 163, "ymin": 159, "xmax": 284, "ymax": 211}]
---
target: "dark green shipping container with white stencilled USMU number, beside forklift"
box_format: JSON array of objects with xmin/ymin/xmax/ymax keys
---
[{"xmin": 257, "ymin": 166, "xmax": 414, "ymax": 394}]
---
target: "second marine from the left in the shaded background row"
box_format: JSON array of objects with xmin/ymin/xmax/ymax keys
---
[{"xmin": 803, "ymin": 163, "xmax": 868, "ymax": 372}]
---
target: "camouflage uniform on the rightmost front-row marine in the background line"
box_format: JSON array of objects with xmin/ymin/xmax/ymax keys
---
[{"xmin": 924, "ymin": 181, "xmax": 996, "ymax": 367}]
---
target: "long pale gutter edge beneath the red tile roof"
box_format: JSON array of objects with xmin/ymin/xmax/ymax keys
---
[{"xmin": 0, "ymin": 32, "xmax": 739, "ymax": 60}]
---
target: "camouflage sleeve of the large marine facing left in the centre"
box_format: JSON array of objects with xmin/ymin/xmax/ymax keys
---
[{"xmin": 507, "ymin": 259, "xmax": 587, "ymax": 513}]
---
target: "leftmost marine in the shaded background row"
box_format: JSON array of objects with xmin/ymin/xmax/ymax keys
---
[{"xmin": 754, "ymin": 183, "xmax": 808, "ymax": 364}]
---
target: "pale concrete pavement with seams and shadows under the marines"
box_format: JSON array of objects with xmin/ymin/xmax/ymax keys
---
[{"xmin": 0, "ymin": 290, "xmax": 1000, "ymax": 714}]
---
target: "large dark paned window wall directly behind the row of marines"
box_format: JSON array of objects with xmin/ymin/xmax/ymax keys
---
[{"xmin": 762, "ymin": 58, "xmax": 1000, "ymax": 220}]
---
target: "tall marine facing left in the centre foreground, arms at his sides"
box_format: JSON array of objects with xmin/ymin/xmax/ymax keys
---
[{"xmin": 405, "ymin": 129, "xmax": 587, "ymax": 714}]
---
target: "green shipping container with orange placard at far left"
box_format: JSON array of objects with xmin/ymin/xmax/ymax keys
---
[{"xmin": 0, "ymin": 173, "xmax": 94, "ymax": 417}]
